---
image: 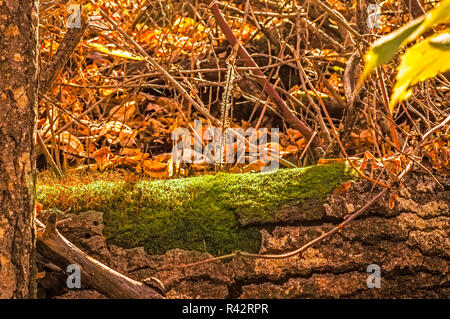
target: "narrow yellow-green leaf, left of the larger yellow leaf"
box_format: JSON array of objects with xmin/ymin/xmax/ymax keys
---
[{"xmin": 362, "ymin": 17, "xmax": 424, "ymax": 78}]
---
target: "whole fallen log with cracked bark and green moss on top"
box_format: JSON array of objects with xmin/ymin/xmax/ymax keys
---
[{"xmin": 38, "ymin": 164, "xmax": 450, "ymax": 298}]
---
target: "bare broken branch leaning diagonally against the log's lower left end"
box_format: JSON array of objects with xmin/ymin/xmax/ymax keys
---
[{"xmin": 37, "ymin": 214, "xmax": 163, "ymax": 299}]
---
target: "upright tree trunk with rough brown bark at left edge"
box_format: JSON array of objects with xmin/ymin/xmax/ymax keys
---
[{"xmin": 0, "ymin": 0, "xmax": 39, "ymax": 298}]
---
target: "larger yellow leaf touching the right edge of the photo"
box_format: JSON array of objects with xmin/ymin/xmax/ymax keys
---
[{"xmin": 390, "ymin": 29, "xmax": 450, "ymax": 111}]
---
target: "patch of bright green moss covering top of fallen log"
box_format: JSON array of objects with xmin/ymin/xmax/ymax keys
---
[{"xmin": 37, "ymin": 163, "xmax": 354, "ymax": 255}]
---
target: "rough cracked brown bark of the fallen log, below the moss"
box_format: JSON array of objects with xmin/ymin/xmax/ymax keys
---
[{"xmin": 47, "ymin": 173, "xmax": 450, "ymax": 298}]
